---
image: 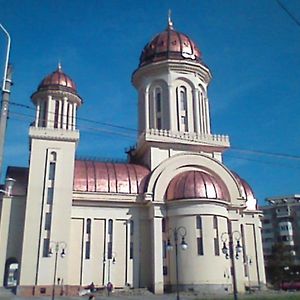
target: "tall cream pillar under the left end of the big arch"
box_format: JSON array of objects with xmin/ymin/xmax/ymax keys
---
[{"xmin": 152, "ymin": 206, "xmax": 164, "ymax": 294}]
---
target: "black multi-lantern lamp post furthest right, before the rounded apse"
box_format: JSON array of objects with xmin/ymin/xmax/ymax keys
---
[{"xmin": 221, "ymin": 230, "xmax": 242, "ymax": 300}]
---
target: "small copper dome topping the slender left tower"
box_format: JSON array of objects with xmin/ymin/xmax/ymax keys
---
[{"xmin": 38, "ymin": 64, "xmax": 77, "ymax": 94}]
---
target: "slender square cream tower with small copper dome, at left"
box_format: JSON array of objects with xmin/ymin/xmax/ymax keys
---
[{"xmin": 19, "ymin": 64, "xmax": 82, "ymax": 294}]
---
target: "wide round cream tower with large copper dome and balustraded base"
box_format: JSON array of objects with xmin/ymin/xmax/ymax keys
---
[{"xmin": 131, "ymin": 17, "xmax": 229, "ymax": 169}]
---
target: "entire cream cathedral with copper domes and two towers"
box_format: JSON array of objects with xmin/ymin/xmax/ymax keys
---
[{"xmin": 0, "ymin": 18, "xmax": 266, "ymax": 296}]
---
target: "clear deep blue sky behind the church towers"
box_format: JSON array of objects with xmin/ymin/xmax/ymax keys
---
[{"xmin": 0, "ymin": 0, "xmax": 300, "ymax": 204}]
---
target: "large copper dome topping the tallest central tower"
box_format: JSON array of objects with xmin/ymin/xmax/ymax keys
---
[{"xmin": 139, "ymin": 22, "xmax": 201, "ymax": 67}]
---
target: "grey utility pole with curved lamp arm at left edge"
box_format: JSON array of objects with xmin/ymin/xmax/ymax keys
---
[{"xmin": 0, "ymin": 24, "xmax": 12, "ymax": 180}]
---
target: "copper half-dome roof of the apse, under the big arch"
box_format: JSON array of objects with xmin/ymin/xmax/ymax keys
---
[{"xmin": 167, "ymin": 171, "xmax": 229, "ymax": 200}]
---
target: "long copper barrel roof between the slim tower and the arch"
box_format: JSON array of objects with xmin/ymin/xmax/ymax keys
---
[{"xmin": 73, "ymin": 160, "xmax": 150, "ymax": 194}]
